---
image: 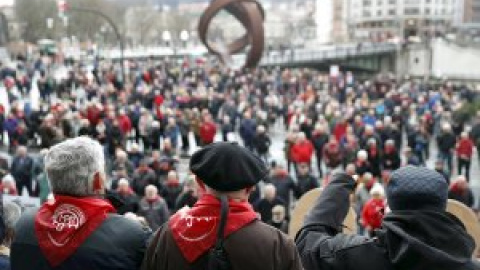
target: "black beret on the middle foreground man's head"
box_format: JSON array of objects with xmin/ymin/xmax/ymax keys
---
[{"xmin": 190, "ymin": 142, "xmax": 268, "ymax": 192}]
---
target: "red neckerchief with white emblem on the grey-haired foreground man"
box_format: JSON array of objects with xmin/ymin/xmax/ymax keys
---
[{"xmin": 35, "ymin": 196, "xmax": 115, "ymax": 267}]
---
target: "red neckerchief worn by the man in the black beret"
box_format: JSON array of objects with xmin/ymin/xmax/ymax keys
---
[{"xmin": 169, "ymin": 194, "xmax": 257, "ymax": 263}]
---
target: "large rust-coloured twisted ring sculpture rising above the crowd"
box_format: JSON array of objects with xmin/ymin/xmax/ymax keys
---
[{"xmin": 198, "ymin": 0, "xmax": 265, "ymax": 68}]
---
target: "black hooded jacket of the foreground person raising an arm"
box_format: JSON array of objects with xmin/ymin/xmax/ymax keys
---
[{"xmin": 295, "ymin": 174, "xmax": 480, "ymax": 270}]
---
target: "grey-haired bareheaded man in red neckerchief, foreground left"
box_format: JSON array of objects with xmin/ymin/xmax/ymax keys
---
[{"xmin": 11, "ymin": 137, "xmax": 151, "ymax": 270}]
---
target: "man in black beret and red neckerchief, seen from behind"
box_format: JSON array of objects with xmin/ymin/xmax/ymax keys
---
[{"xmin": 142, "ymin": 143, "xmax": 302, "ymax": 270}]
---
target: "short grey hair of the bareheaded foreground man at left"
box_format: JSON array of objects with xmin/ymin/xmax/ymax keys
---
[{"xmin": 45, "ymin": 137, "xmax": 105, "ymax": 197}]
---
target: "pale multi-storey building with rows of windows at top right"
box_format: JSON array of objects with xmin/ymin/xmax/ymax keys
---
[{"xmin": 343, "ymin": 0, "xmax": 462, "ymax": 41}]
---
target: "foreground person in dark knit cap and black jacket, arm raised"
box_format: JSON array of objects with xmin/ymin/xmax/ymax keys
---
[{"xmin": 295, "ymin": 166, "xmax": 480, "ymax": 270}]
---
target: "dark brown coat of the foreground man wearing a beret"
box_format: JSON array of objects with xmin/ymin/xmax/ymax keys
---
[{"xmin": 142, "ymin": 221, "xmax": 302, "ymax": 270}]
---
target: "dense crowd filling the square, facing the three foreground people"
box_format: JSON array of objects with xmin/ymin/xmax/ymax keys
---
[{"xmin": 0, "ymin": 52, "xmax": 480, "ymax": 269}]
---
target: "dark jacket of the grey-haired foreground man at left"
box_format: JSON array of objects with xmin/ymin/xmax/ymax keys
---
[{"xmin": 11, "ymin": 211, "xmax": 151, "ymax": 270}]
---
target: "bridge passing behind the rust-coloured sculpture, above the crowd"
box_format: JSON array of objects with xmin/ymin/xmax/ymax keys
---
[{"xmin": 100, "ymin": 43, "xmax": 399, "ymax": 73}]
